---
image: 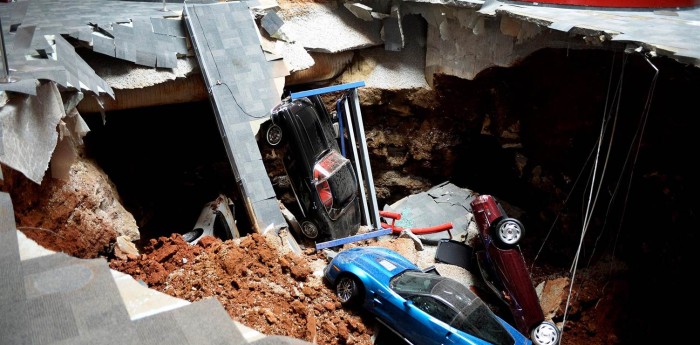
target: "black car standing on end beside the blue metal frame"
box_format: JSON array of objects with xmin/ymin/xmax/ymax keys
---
[{"xmin": 266, "ymin": 96, "xmax": 361, "ymax": 240}]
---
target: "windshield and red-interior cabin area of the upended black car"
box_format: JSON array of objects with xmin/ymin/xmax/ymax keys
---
[{"xmin": 313, "ymin": 150, "xmax": 357, "ymax": 219}]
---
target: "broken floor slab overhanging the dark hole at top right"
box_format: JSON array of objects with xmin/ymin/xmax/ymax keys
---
[{"xmin": 402, "ymin": 0, "xmax": 700, "ymax": 85}]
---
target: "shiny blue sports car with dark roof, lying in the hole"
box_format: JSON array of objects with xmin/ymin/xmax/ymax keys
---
[{"xmin": 324, "ymin": 247, "xmax": 531, "ymax": 345}]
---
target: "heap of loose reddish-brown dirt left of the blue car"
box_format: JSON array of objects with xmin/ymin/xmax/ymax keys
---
[{"xmin": 110, "ymin": 234, "xmax": 374, "ymax": 344}]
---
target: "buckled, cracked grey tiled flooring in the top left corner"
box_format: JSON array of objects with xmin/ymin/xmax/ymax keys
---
[{"xmin": 0, "ymin": 0, "xmax": 197, "ymax": 98}]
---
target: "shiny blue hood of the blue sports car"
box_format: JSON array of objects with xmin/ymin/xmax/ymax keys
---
[{"xmin": 339, "ymin": 247, "xmax": 419, "ymax": 283}]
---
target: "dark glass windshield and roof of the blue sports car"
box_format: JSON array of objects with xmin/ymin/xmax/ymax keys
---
[{"xmin": 390, "ymin": 271, "xmax": 514, "ymax": 345}]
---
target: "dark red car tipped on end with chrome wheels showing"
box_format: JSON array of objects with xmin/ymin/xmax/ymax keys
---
[{"xmin": 471, "ymin": 195, "xmax": 561, "ymax": 345}]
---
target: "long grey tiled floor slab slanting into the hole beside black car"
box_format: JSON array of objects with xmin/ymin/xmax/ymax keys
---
[{"xmin": 185, "ymin": 2, "xmax": 287, "ymax": 233}]
